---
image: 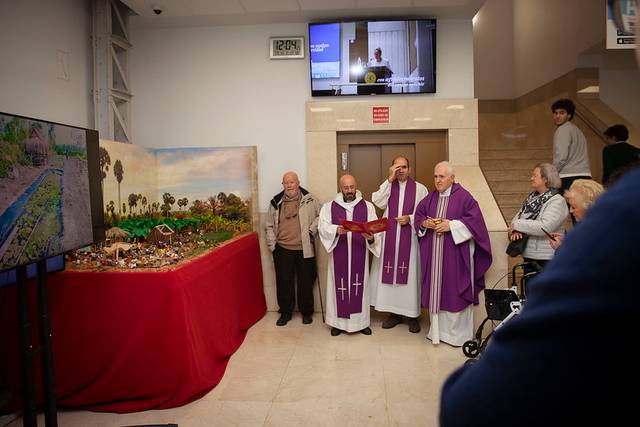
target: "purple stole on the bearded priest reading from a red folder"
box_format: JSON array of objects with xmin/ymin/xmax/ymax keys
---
[{"xmin": 331, "ymin": 200, "xmax": 369, "ymax": 319}]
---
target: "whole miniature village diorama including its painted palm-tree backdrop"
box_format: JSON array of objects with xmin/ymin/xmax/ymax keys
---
[{"xmin": 80, "ymin": 140, "xmax": 255, "ymax": 269}]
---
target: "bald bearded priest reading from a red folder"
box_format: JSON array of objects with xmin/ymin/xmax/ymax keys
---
[{"xmin": 318, "ymin": 175, "xmax": 380, "ymax": 336}]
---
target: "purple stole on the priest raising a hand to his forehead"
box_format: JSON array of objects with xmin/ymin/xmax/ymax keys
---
[{"xmin": 382, "ymin": 178, "xmax": 416, "ymax": 285}]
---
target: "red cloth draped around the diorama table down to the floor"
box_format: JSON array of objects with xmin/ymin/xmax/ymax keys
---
[{"xmin": 0, "ymin": 233, "xmax": 266, "ymax": 412}]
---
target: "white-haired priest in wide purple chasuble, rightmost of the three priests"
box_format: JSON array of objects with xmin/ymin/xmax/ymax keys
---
[{"xmin": 414, "ymin": 162, "xmax": 491, "ymax": 346}]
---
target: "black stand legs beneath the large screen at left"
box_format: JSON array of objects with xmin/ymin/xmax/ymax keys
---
[{"xmin": 16, "ymin": 260, "xmax": 58, "ymax": 427}]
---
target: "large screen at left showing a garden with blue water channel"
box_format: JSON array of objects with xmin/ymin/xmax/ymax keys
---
[{"xmin": 0, "ymin": 113, "xmax": 104, "ymax": 271}]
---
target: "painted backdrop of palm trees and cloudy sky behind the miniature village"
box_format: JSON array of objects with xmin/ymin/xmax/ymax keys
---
[{"xmin": 100, "ymin": 140, "xmax": 255, "ymax": 238}]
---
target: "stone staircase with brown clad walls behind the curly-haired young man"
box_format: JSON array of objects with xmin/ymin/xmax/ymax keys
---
[{"xmin": 478, "ymin": 68, "xmax": 640, "ymax": 224}]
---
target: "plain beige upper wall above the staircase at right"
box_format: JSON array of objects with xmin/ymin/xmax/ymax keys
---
[{"xmin": 473, "ymin": 0, "xmax": 605, "ymax": 99}]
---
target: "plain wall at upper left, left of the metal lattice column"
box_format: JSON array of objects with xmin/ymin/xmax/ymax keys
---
[{"xmin": 0, "ymin": 0, "xmax": 93, "ymax": 128}]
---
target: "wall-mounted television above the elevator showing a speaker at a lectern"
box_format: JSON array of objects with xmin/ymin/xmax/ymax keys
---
[{"xmin": 309, "ymin": 19, "xmax": 436, "ymax": 96}]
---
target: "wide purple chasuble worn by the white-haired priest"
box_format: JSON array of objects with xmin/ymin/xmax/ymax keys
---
[{"xmin": 414, "ymin": 183, "xmax": 492, "ymax": 313}]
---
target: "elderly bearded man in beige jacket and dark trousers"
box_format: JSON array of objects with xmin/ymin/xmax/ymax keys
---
[{"xmin": 265, "ymin": 171, "xmax": 321, "ymax": 326}]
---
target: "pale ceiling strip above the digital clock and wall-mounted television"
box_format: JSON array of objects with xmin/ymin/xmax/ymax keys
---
[{"xmin": 121, "ymin": 0, "xmax": 485, "ymax": 28}]
